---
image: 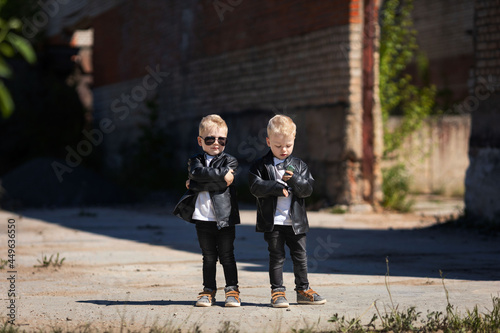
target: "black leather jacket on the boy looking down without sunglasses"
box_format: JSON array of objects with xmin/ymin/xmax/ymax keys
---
[{"xmin": 248, "ymin": 151, "xmax": 314, "ymax": 235}]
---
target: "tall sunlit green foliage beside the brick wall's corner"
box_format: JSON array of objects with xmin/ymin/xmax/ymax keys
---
[{"xmin": 379, "ymin": 0, "xmax": 436, "ymax": 156}]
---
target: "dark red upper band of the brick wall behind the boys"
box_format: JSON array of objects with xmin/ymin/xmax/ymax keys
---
[{"xmin": 93, "ymin": 0, "xmax": 352, "ymax": 86}]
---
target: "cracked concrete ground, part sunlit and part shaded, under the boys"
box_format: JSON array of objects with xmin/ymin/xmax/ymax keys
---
[{"xmin": 0, "ymin": 197, "xmax": 500, "ymax": 332}]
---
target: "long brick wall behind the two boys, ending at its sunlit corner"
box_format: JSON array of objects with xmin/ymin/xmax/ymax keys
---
[{"xmin": 94, "ymin": 0, "xmax": 363, "ymax": 203}]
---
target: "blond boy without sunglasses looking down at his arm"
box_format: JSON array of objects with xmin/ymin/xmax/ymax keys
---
[{"xmin": 249, "ymin": 115, "xmax": 326, "ymax": 308}]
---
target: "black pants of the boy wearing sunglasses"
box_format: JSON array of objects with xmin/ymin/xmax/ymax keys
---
[{"xmin": 196, "ymin": 221, "xmax": 238, "ymax": 290}]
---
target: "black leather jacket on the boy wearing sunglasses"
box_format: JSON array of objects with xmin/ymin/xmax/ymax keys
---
[{"xmin": 174, "ymin": 152, "xmax": 240, "ymax": 229}]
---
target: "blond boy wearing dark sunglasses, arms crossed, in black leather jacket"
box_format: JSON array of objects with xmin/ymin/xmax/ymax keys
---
[{"xmin": 174, "ymin": 115, "xmax": 241, "ymax": 307}]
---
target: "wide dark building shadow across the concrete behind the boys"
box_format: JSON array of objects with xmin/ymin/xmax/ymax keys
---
[{"xmin": 20, "ymin": 204, "xmax": 500, "ymax": 281}]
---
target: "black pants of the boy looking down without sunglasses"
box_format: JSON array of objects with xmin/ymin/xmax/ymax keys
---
[{"xmin": 264, "ymin": 225, "xmax": 309, "ymax": 290}]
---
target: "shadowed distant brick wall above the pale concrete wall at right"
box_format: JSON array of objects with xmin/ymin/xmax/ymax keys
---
[{"xmin": 411, "ymin": 0, "xmax": 474, "ymax": 107}]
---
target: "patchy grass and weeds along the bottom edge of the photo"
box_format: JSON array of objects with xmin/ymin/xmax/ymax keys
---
[{"xmin": 0, "ymin": 259, "xmax": 500, "ymax": 333}]
